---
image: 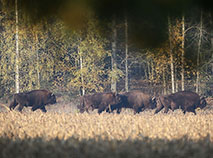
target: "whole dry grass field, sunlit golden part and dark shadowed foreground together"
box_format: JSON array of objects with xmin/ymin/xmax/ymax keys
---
[{"xmin": 0, "ymin": 99, "xmax": 213, "ymax": 158}]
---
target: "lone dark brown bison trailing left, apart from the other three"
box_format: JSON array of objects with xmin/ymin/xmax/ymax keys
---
[{"xmin": 10, "ymin": 90, "xmax": 56, "ymax": 112}]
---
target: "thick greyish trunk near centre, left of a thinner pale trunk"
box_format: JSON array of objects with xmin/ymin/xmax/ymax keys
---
[{"xmin": 111, "ymin": 15, "xmax": 117, "ymax": 92}]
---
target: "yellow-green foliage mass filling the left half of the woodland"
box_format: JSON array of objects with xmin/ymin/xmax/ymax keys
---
[{"xmin": 0, "ymin": 6, "xmax": 110, "ymax": 96}]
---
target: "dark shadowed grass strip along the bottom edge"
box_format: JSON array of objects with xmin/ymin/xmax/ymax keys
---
[{"xmin": 0, "ymin": 136, "xmax": 213, "ymax": 158}]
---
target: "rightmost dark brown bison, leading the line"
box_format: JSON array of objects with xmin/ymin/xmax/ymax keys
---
[{"xmin": 155, "ymin": 91, "xmax": 206, "ymax": 114}]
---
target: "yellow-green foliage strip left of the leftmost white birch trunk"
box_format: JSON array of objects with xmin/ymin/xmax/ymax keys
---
[{"xmin": 0, "ymin": 9, "xmax": 15, "ymax": 97}]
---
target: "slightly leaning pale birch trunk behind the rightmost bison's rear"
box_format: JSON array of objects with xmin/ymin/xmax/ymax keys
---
[{"xmin": 168, "ymin": 16, "xmax": 175, "ymax": 93}]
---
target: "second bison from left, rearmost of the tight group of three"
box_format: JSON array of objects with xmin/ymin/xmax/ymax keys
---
[{"xmin": 78, "ymin": 92, "xmax": 120, "ymax": 114}]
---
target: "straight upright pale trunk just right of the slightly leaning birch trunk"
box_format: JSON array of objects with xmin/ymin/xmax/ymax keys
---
[{"xmin": 181, "ymin": 15, "xmax": 185, "ymax": 91}]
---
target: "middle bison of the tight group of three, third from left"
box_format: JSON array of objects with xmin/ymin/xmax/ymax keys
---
[{"xmin": 112, "ymin": 90, "xmax": 156, "ymax": 114}]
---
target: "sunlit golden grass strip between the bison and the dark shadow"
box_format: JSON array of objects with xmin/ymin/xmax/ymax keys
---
[{"xmin": 0, "ymin": 110, "xmax": 213, "ymax": 141}]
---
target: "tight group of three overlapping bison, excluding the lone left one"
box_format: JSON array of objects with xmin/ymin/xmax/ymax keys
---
[{"xmin": 78, "ymin": 91, "xmax": 207, "ymax": 114}]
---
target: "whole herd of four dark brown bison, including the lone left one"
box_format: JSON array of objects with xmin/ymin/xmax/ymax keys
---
[{"xmin": 9, "ymin": 90, "xmax": 207, "ymax": 114}]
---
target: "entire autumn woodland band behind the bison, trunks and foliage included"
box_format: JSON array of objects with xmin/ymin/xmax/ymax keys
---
[{"xmin": 0, "ymin": 1, "xmax": 213, "ymax": 98}]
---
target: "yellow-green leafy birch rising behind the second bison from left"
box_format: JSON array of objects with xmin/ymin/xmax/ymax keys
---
[{"xmin": 69, "ymin": 16, "xmax": 109, "ymax": 92}]
